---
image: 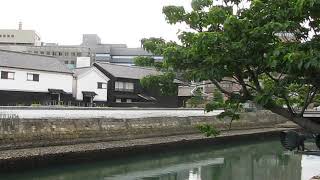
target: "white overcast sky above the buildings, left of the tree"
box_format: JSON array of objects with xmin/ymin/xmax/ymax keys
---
[{"xmin": 0, "ymin": 0, "xmax": 195, "ymax": 47}]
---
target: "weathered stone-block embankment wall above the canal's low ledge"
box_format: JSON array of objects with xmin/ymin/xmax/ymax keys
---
[{"xmin": 0, "ymin": 111, "xmax": 287, "ymax": 150}]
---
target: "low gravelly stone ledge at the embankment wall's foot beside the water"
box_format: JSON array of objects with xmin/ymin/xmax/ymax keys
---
[{"xmin": 0, "ymin": 128, "xmax": 292, "ymax": 171}]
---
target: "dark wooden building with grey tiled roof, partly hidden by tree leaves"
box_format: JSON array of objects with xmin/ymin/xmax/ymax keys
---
[{"xmin": 93, "ymin": 62, "xmax": 178, "ymax": 107}]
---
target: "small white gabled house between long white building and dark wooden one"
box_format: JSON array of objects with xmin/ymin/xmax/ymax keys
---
[{"xmin": 73, "ymin": 66, "xmax": 110, "ymax": 106}]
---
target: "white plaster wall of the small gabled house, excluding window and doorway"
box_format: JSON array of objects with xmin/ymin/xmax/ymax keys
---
[{"xmin": 76, "ymin": 68, "xmax": 109, "ymax": 101}]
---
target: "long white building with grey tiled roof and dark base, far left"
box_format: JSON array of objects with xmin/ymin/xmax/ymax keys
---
[{"xmin": 0, "ymin": 50, "xmax": 73, "ymax": 105}]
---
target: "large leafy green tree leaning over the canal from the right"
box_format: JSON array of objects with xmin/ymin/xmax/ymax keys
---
[{"xmin": 142, "ymin": 0, "xmax": 320, "ymax": 133}]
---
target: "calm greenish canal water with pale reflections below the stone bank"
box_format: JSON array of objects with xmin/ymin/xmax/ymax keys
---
[{"xmin": 0, "ymin": 140, "xmax": 320, "ymax": 180}]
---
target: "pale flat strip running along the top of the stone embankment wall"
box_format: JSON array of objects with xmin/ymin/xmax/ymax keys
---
[{"xmin": 0, "ymin": 107, "xmax": 223, "ymax": 119}]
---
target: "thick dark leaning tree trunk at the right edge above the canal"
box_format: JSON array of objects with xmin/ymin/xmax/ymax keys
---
[{"xmin": 267, "ymin": 106, "xmax": 320, "ymax": 134}]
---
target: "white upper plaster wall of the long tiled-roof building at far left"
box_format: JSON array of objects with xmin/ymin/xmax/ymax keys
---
[{"xmin": 0, "ymin": 67, "xmax": 73, "ymax": 93}]
